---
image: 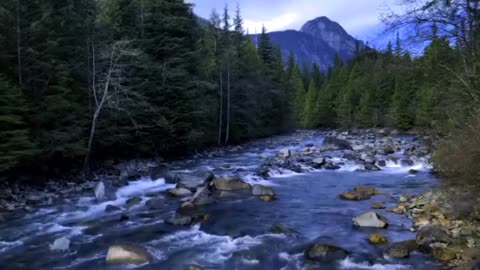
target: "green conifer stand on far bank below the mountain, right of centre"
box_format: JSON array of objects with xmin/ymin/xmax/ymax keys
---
[{"xmin": 291, "ymin": 36, "xmax": 458, "ymax": 130}]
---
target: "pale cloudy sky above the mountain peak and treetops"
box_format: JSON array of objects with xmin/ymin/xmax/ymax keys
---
[{"xmin": 188, "ymin": 0, "xmax": 398, "ymax": 43}]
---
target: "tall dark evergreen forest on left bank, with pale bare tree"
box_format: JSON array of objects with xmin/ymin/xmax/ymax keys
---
[{"xmin": 0, "ymin": 0, "xmax": 292, "ymax": 178}]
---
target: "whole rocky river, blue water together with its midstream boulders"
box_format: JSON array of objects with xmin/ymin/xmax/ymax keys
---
[{"xmin": 0, "ymin": 131, "xmax": 468, "ymax": 269}]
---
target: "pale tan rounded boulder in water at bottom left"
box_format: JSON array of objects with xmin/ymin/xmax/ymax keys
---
[{"xmin": 106, "ymin": 245, "xmax": 152, "ymax": 264}]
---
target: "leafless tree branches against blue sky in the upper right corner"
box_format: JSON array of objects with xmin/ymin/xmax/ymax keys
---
[{"xmin": 383, "ymin": 0, "xmax": 480, "ymax": 103}]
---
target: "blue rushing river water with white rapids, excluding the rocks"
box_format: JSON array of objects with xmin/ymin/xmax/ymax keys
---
[{"xmin": 0, "ymin": 134, "xmax": 438, "ymax": 270}]
